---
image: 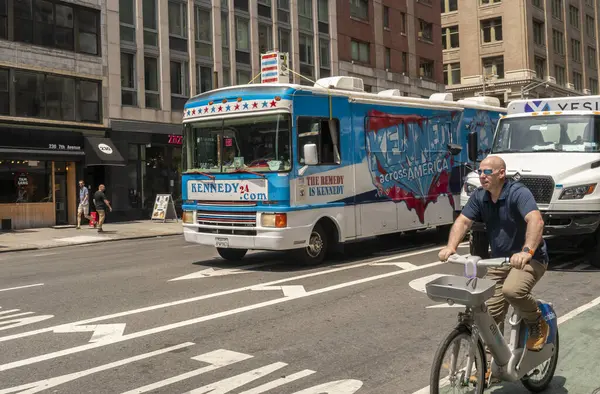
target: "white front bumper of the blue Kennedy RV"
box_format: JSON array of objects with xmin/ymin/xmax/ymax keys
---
[{"xmin": 183, "ymin": 224, "xmax": 311, "ymax": 250}]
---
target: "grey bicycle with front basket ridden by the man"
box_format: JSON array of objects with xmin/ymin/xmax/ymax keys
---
[{"xmin": 425, "ymin": 254, "xmax": 559, "ymax": 394}]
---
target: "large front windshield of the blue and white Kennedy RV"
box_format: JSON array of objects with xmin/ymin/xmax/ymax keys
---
[{"xmin": 183, "ymin": 114, "xmax": 291, "ymax": 173}]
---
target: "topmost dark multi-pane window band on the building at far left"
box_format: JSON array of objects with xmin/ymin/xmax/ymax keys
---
[{"xmin": 11, "ymin": 0, "xmax": 100, "ymax": 55}]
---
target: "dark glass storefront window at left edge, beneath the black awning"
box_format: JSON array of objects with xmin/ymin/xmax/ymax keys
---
[{"xmin": 0, "ymin": 160, "xmax": 52, "ymax": 204}]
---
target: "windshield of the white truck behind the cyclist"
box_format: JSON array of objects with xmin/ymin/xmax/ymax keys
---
[{"xmin": 492, "ymin": 115, "xmax": 600, "ymax": 153}]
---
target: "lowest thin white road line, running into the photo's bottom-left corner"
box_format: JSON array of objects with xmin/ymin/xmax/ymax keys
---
[{"xmin": 0, "ymin": 342, "xmax": 194, "ymax": 394}]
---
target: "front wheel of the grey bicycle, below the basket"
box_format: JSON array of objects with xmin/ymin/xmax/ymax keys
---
[{"xmin": 429, "ymin": 325, "xmax": 486, "ymax": 394}]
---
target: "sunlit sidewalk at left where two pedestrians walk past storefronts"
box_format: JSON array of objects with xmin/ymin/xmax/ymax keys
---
[{"xmin": 0, "ymin": 220, "xmax": 183, "ymax": 253}]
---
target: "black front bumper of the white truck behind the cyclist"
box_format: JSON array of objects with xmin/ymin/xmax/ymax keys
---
[{"xmin": 471, "ymin": 211, "xmax": 600, "ymax": 235}]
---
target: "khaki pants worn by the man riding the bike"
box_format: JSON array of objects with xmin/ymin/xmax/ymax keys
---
[{"xmin": 485, "ymin": 260, "xmax": 547, "ymax": 333}]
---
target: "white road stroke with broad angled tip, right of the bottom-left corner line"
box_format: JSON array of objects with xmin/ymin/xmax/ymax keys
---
[{"xmin": 120, "ymin": 349, "xmax": 254, "ymax": 394}]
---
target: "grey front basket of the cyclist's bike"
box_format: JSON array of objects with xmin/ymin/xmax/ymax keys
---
[{"xmin": 425, "ymin": 275, "xmax": 496, "ymax": 307}]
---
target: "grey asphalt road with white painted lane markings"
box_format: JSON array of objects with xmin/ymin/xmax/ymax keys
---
[{"xmin": 0, "ymin": 234, "xmax": 600, "ymax": 394}]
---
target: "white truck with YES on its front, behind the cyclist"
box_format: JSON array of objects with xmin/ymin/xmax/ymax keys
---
[{"xmin": 460, "ymin": 96, "xmax": 600, "ymax": 267}]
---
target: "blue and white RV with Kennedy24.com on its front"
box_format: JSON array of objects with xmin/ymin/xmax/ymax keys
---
[{"xmin": 182, "ymin": 77, "xmax": 505, "ymax": 264}]
